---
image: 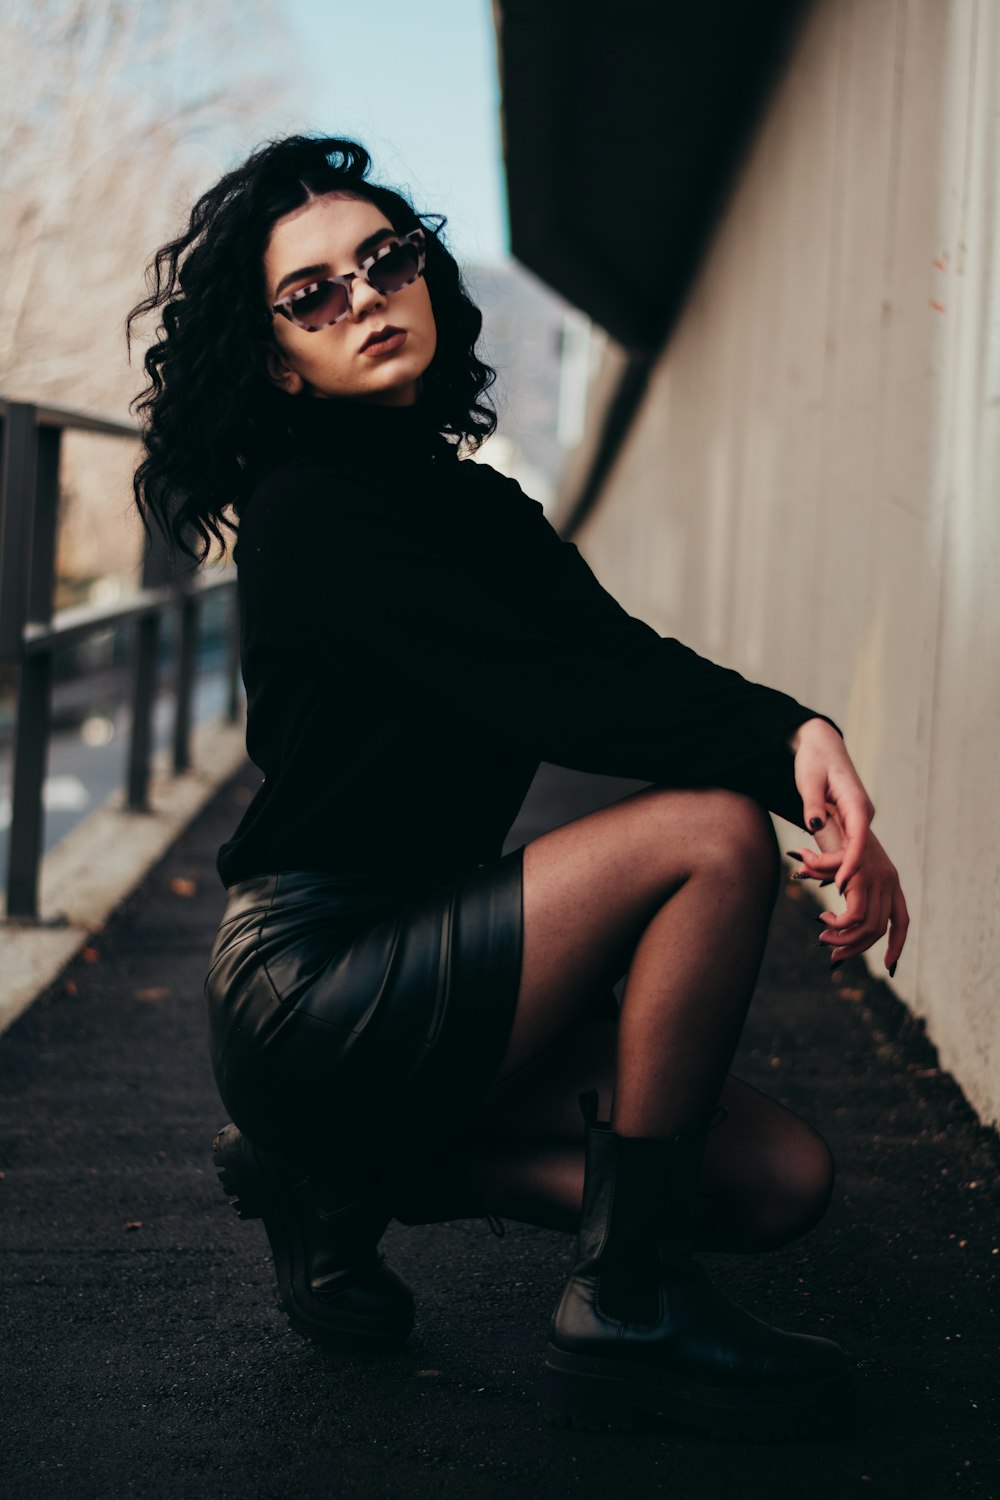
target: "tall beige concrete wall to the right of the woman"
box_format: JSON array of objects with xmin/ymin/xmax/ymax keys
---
[{"xmin": 574, "ymin": 0, "xmax": 1000, "ymax": 1124}]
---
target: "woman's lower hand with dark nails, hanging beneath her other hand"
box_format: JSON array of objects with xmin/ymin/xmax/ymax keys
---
[{"xmin": 789, "ymin": 812, "xmax": 910, "ymax": 978}]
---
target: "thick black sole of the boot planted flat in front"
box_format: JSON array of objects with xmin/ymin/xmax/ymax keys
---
[{"xmin": 541, "ymin": 1344, "xmax": 856, "ymax": 1443}]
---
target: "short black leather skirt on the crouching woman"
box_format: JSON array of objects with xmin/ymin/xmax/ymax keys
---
[{"xmin": 205, "ymin": 846, "xmax": 523, "ymax": 1200}]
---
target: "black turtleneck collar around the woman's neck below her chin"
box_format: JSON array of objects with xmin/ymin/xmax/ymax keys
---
[{"xmin": 275, "ymin": 396, "xmax": 456, "ymax": 467}]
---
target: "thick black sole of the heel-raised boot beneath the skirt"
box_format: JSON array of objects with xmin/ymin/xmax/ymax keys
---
[{"xmin": 211, "ymin": 1125, "xmax": 414, "ymax": 1352}]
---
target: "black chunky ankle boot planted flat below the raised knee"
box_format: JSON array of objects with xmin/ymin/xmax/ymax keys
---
[{"xmin": 543, "ymin": 1089, "xmax": 855, "ymax": 1440}]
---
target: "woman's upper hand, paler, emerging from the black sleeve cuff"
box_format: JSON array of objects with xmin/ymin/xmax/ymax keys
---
[{"xmin": 789, "ymin": 719, "xmax": 876, "ymax": 894}]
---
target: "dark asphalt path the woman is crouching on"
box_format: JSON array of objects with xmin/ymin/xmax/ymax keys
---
[{"xmin": 0, "ymin": 765, "xmax": 1000, "ymax": 1500}]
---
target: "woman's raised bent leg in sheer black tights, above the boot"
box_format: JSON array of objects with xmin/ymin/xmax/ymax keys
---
[{"xmin": 484, "ymin": 786, "xmax": 780, "ymax": 1134}]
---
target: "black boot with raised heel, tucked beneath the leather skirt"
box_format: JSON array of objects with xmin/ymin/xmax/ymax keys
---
[{"xmin": 213, "ymin": 1125, "xmax": 414, "ymax": 1350}]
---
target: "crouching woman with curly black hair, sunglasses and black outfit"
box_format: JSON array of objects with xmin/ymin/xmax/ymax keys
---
[{"xmin": 129, "ymin": 137, "xmax": 907, "ymax": 1436}]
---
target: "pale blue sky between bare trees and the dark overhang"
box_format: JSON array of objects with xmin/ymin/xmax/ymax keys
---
[{"xmin": 274, "ymin": 0, "xmax": 508, "ymax": 264}]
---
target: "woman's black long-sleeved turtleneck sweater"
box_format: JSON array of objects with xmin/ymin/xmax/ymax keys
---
[{"xmin": 217, "ymin": 396, "xmax": 837, "ymax": 887}]
